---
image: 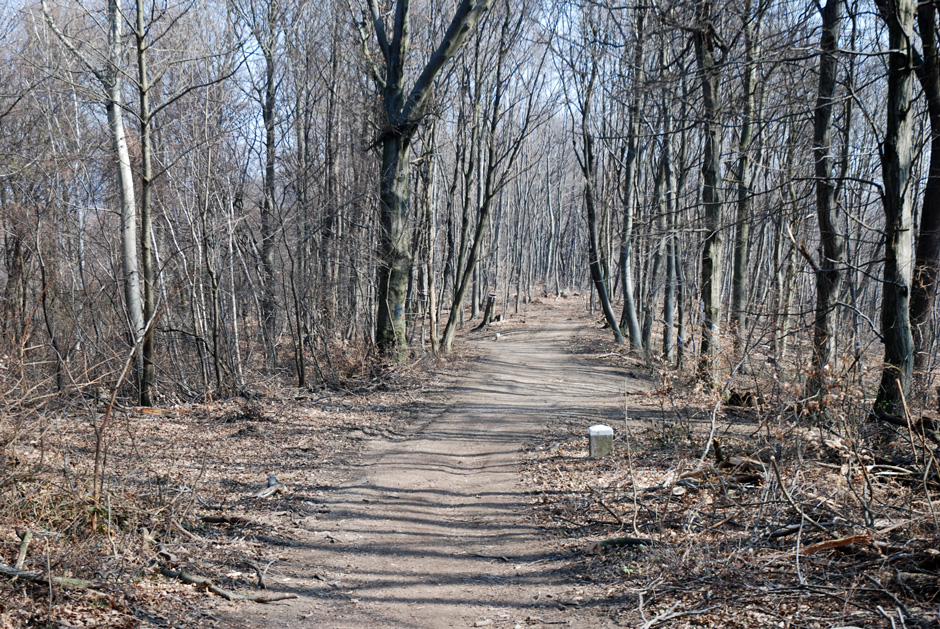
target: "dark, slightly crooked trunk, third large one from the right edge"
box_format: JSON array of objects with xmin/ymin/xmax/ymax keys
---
[{"xmin": 806, "ymin": 0, "xmax": 845, "ymax": 397}]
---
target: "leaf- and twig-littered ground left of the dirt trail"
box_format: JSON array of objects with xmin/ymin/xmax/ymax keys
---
[{"xmin": 0, "ymin": 353, "xmax": 466, "ymax": 628}]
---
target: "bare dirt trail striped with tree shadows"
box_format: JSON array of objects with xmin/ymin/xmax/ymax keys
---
[{"xmin": 214, "ymin": 302, "xmax": 635, "ymax": 629}]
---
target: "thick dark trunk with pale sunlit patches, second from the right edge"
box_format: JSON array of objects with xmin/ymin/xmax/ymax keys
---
[{"xmin": 875, "ymin": 0, "xmax": 915, "ymax": 418}]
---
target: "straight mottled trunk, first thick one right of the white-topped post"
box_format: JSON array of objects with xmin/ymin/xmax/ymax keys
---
[{"xmin": 694, "ymin": 0, "xmax": 722, "ymax": 383}]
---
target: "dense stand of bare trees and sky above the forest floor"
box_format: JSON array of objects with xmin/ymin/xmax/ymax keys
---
[{"xmin": 0, "ymin": 0, "xmax": 940, "ymax": 412}]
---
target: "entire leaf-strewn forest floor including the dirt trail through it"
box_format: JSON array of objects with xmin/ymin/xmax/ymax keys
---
[{"xmin": 0, "ymin": 299, "xmax": 940, "ymax": 629}]
